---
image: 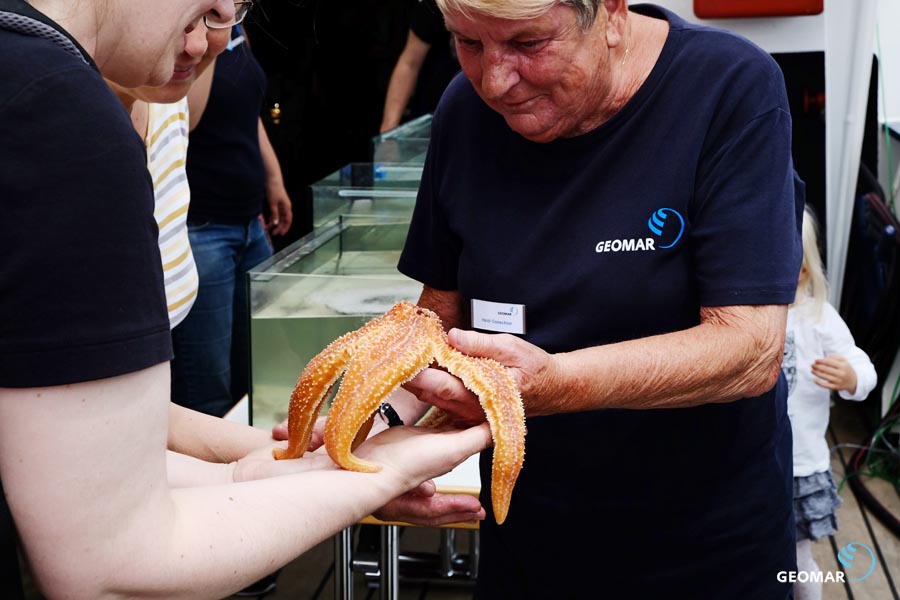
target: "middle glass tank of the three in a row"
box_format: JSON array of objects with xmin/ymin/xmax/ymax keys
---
[{"xmin": 310, "ymin": 163, "xmax": 422, "ymax": 229}]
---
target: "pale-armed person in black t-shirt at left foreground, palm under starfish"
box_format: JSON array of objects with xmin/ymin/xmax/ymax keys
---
[{"xmin": 0, "ymin": 0, "xmax": 490, "ymax": 598}]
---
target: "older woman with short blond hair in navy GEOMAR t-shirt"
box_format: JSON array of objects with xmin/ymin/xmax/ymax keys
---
[{"xmin": 380, "ymin": 0, "xmax": 803, "ymax": 599}]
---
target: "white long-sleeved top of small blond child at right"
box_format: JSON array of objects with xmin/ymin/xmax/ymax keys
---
[{"xmin": 781, "ymin": 302, "xmax": 878, "ymax": 477}]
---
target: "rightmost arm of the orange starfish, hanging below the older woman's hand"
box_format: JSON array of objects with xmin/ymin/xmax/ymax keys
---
[{"xmin": 437, "ymin": 345, "xmax": 525, "ymax": 525}]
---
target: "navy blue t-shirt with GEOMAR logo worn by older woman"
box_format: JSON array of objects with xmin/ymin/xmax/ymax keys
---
[{"xmin": 399, "ymin": 5, "xmax": 803, "ymax": 598}]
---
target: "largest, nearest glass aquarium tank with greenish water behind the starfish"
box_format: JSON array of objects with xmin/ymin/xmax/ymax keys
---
[{"xmin": 248, "ymin": 215, "xmax": 422, "ymax": 430}]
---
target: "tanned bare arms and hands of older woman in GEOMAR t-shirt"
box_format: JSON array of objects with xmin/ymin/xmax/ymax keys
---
[{"xmin": 415, "ymin": 294, "xmax": 787, "ymax": 420}]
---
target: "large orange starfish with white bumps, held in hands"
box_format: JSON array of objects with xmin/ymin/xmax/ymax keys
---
[{"xmin": 274, "ymin": 302, "xmax": 525, "ymax": 523}]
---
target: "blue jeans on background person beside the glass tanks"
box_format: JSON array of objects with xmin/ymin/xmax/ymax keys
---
[{"xmin": 172, "ymin": 218, "xmax": 272, "ymax": 417}]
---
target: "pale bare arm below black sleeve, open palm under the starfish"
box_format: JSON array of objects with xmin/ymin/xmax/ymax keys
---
[{"xmin": 0, "ymin": 363, "xmax": 490, "ymax": 599}]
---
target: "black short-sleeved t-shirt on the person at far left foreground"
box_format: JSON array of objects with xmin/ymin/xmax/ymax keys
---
[{"xmin": 0, "ymin": 24, "xmax": 171, "ymax": 387}]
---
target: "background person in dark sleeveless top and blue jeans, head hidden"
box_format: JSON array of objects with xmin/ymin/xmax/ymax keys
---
[{"xmin": 172, "ymin": 25, "xmax": 292, "ymax": 417}]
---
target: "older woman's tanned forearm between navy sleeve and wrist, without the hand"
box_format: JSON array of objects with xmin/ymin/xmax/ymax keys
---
[{"xmin": 544, "ymin": 306, "xmax": 786, "ymax": 414}]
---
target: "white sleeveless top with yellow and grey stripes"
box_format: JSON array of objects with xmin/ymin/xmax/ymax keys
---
[{"xmin": 144, "ymin": 100, "xmax": 198, "ymax": 327}]
